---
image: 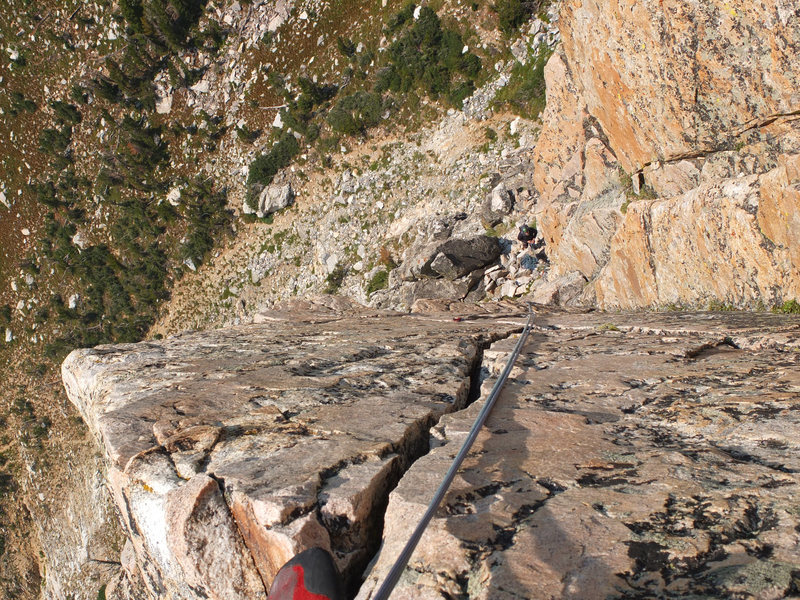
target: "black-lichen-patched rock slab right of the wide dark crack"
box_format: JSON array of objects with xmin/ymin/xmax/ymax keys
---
[{"xmin": 358, "ymin": 313, "xmax": 800, "ymax": 600}]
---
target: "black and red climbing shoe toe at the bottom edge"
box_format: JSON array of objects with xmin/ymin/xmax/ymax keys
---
[{"xmin": 269, "ymin": 548, "xmax": 345, "ymax": 600}]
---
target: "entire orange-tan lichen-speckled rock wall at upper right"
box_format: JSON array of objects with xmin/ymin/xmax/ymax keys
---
[{"xmin": 534, "ymin": 0, "xmax": 800, "ymax": 307}]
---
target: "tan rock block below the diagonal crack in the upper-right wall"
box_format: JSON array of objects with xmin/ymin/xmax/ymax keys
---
[{"xmin": 595, "ymin": 168, "xmax": 800, "ymax": 308}]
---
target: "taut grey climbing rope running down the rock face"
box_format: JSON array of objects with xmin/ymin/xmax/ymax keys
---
[{"xmin": 372, "ymin": 308, "xmax": 534, "ymax": 600}]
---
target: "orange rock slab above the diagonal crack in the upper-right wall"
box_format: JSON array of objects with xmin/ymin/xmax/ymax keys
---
[{"xmin": 560, "ymin": 0, "xmax": 800, "ymax": 171}]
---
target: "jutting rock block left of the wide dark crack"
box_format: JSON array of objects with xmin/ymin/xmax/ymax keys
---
[{"xmin": 63, "ymin": 306, "xmax": 519, "ymax": 600}]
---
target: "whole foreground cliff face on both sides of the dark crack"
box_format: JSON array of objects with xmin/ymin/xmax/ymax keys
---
[{"xmin": 63, "ymin": 303, "xmax": 800, "ymax": 600}]
